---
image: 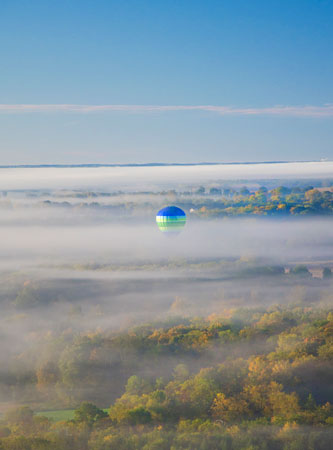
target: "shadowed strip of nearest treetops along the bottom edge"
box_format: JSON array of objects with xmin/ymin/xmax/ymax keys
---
[{"xmin": 0, "ymin": 403, "xmax": 333, "ymax": 450}]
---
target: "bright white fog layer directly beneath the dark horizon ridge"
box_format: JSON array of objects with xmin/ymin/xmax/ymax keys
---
[{"xmin": 0, "ymin": 161, "xmax": 333, "ymax": 192}]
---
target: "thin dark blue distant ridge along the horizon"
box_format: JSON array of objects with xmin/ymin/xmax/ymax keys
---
[{"xmin": 0, "ymin": 160, "xmax": 322, "ymax": 169}]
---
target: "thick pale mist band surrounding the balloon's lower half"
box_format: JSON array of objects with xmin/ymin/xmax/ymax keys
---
[{"xmin": 0, "ymin": 209, "xmax": 333, "ymax": 267}]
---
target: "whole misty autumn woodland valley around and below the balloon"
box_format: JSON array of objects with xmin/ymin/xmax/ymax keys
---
[{"xmin": 0, "ymin": 171, "xmax": 333, "ymax": 450}]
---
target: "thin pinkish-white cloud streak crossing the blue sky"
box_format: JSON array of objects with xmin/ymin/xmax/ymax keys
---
[{"xmin": 0, "ymin": 104, "xmax": 333, "ymax": 118}]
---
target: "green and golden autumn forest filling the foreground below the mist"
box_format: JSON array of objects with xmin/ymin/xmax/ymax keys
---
[{"xmin": 0, "ymin": 304, "xmax": 333, "ymax": 450}]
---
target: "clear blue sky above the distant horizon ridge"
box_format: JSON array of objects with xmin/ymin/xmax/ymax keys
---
[{"xmin": 0, "ymin": 0, "xmax": 333, "ymax": 164}]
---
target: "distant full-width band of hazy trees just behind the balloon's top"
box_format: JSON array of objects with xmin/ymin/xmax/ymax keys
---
[{"xmin": 0, "ymin": 186, "xmax": 333, "ymax": 219}]
